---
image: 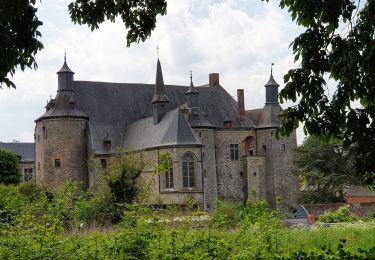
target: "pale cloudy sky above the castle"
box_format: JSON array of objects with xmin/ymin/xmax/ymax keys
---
[{"xmin": 0, "ymin": 0, "xmax": 304, "ymax": 143}]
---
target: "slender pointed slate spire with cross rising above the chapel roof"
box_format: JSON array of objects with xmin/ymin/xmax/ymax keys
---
[{"xmin": 152, "ymin": 59, "xmax": 169, "ymax": 125}]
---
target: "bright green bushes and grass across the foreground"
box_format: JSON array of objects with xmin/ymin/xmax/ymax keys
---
[{"xmin": 0, "ymin": 183, "xmax": 375, "ymax": 259}]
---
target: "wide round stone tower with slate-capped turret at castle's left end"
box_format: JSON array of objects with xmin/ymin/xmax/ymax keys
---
[{"xmin": 35, "ymin": 57, "xmax": 88, "ymax": 188}]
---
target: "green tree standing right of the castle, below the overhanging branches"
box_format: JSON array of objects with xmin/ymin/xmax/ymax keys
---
[{"xmin": 293, "ymin": 136, "xmax": 364, "ymax": 203}]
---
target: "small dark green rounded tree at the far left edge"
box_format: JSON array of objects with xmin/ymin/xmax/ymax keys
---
[{"xmin": 0, "ymin": 148, "xmax": 21, "ymax": 184}]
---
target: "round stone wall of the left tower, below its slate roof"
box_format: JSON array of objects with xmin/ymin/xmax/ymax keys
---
[{"xmin": 35, "ymin": 118, "xmax": 88, "ymax": 189}]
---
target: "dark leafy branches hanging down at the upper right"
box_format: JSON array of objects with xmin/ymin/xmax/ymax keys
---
[{"xmin": 268, "ymin": 0, "xmax": 375, "ymax": 186}]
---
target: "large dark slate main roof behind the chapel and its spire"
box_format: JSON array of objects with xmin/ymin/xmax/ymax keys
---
[{"xmin": 73, "ymin": 81, "xmax": 255, "ymax": 154}]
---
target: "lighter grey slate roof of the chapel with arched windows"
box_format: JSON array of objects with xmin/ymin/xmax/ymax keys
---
[{"xmin": 123, "ymin": 108, "xmax": 201, "ymax": 150}]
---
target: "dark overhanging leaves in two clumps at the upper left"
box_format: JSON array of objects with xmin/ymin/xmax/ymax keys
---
[{"xmin": 0, "ymin": 0, "xmax": 167, "ymax": 88}]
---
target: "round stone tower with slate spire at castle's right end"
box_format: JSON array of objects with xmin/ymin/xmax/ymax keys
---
[{"xmin": 249, "ymin": 64, "xmax": 299, "ymax": 208}]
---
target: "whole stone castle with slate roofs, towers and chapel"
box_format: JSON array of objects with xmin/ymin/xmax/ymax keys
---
[{"xmin": 35, "ymin": 59, "xmax": 298, "ymax": 210}]
